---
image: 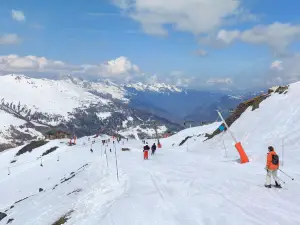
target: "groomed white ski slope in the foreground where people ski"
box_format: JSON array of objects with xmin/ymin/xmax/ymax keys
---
[{"xmin": 0, "ymin": 83, "xmax": 300, "ymax": 225}]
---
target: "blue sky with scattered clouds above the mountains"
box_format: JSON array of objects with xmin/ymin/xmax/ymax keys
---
[{"xmin": 0, "ymin": 0, "xmax": 300, "ymax": 89}]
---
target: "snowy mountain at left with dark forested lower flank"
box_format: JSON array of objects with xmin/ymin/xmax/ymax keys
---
[{"xmin": 0, "ymin": 75, "xmax": 179, "ymax": 150}]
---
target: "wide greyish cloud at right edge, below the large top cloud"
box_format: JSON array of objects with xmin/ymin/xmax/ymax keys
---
[{"xmin": 216, "ymin": 22, "xmax": 300, "ymax": 52}]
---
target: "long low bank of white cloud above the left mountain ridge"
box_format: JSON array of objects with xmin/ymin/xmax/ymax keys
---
[{"xmin": 0, "ymin": 55, "xmax": 195, "ymax": 86}]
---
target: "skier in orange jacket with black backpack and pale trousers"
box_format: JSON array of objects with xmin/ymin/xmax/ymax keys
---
[{"xmin": 265, "ymin": 146, "xmax": 281, "ymax": 188}]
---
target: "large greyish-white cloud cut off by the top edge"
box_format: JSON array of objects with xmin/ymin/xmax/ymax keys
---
[{"xmin": 112, "ymin": 0, "xmax": 242, "ymax": 35}]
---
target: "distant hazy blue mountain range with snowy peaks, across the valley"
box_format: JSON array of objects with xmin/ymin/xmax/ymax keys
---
[{"xmin": 62, "ymin": 76, "xmax": 244, "ymax": 124}]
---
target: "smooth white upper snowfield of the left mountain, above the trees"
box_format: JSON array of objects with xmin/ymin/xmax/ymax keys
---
[{"xmin": 0, "ymin": 75, "xmax": 109, "ymax": 117}]
